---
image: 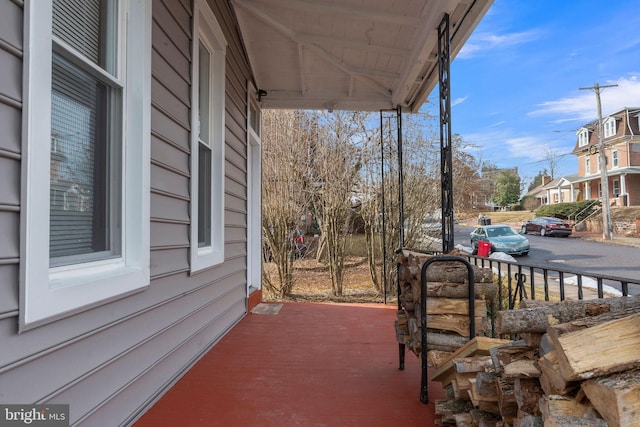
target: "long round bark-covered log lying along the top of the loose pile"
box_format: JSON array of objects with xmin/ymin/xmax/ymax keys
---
[{"xmin": 495, "ymin": 295, "xmax": 640, "ymax": 335}]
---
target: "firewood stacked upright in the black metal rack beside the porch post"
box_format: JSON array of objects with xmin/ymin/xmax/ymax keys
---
[{"xmin": 396, "ymin": 250, "xmax": 497, "ymax": 356}]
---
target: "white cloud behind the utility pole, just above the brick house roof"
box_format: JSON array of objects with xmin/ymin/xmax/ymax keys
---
[{"xmin": 529, "ymin": 75, "xmax": 640, "ymax": 124}]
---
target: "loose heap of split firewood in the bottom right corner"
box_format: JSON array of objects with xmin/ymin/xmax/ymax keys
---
[{"xmin": 432, "ymin": 296, "xmax": 640, "ymax": 427}]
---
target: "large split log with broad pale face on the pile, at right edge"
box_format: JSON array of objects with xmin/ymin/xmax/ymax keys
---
[{"xmin": 550, "ymin": 312, "xmax": 640, "ymax": 381}]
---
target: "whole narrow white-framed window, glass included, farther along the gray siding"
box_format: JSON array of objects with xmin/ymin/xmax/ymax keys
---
[{"xmin": 190, "ymin": 0, "xmax": 227, "ymax": 273}]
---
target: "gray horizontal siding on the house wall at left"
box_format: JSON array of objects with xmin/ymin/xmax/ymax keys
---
[{"xmin": 0, "ymin": 0, "xmax": 255, "ymax": 427}]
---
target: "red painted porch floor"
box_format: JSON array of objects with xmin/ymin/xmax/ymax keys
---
[{"xmin": 135, "ymin": 303, "xmax": 444, "ymax": 427}]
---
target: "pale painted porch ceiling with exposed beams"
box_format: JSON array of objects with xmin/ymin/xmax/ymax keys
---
[{"xmin": 232, "ymin": 0, "xmax": 493, "ymax": 112}]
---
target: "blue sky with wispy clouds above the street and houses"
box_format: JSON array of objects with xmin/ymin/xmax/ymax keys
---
[{"xmin": 431, "ymin": 0, "xmax": 640, "ymax": 184}]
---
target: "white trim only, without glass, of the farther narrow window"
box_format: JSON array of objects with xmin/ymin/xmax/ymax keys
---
[{"xmin": 191, "ymin": 0, "xmax": 227, "ymax": 273}]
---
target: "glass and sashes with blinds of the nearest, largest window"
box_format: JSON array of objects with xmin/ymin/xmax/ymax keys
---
[{"xmin": 49, "ymin": 0, "xmax": 122, "ymax": 266}]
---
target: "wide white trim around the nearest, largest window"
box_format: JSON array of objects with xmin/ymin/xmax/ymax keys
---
[{"xmin": 19, "ymin": 0, "xmax": 151, "ymax": 331}]
